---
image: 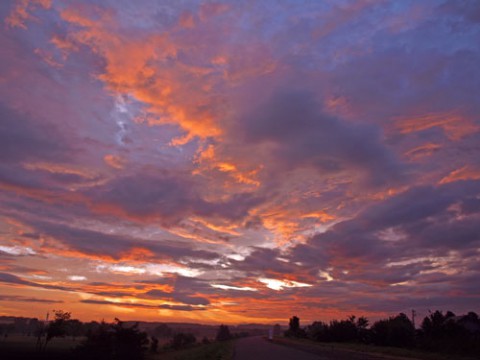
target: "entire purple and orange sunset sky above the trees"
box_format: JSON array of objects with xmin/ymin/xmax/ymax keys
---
[{"xmin": 0, "ymin": 0, "xmax": 480, "ymax": 324}]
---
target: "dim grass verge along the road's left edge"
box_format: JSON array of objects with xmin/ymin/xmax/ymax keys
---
[{"xmin": 147, "ymin": 341, "xmax": 234, "ymax": 360}]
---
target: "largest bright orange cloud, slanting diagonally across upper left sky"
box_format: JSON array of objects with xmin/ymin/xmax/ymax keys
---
[{"xmin": 61, "ymin": 7, "xmax": 225, "ymax": 145}]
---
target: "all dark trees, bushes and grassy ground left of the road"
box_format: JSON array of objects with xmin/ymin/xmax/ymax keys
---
[{"xmin": 0, "ymin": 311, "xmax": 238, "ymax": 360}]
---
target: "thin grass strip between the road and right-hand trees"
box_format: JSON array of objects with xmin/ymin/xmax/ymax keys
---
[{"xmin": 274, "ymin": 338, "xmax": 473, "ymax": 360}]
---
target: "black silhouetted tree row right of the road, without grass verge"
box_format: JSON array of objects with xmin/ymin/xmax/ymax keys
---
[{"xmin": 285, "ymin": 310, "xmax": 480, "ymax": 356}]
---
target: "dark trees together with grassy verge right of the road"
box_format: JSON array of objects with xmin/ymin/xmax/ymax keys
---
[{"xmin": 275, "ymin": 311, "xmax": 480, "ymax": 360}]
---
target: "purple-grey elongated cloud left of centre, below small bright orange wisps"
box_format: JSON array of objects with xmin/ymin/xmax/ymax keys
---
[{"xmin": 88, "ymin": 168, "xmax": 262, "ymax": 224}]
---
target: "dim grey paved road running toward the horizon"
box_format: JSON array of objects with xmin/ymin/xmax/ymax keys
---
[{"xmin": 235, "ymin": 336, "xmax": 329, "ymax": 360}]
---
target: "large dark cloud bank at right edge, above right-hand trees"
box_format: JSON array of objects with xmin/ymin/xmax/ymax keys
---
[{"xmin": 289, "ymin": 181, "xmax": 480, "ymax": 292}]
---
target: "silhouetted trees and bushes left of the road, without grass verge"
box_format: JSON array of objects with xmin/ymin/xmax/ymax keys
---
[{"xmin": 0, "ymin": 310, "xmax": 237, "ymax": 360}]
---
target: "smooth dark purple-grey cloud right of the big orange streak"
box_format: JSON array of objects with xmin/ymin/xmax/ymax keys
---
[{"xmin": 237, "ymin": 91, "xmax": 406, "ymax": 185}]
